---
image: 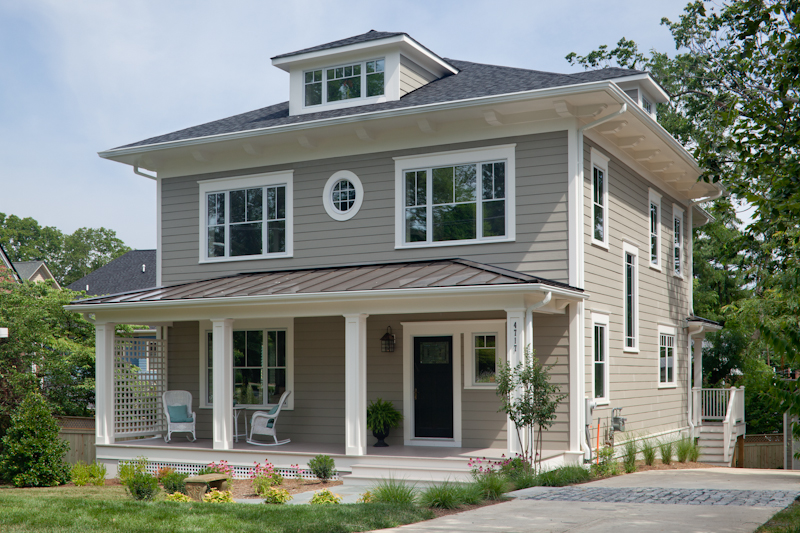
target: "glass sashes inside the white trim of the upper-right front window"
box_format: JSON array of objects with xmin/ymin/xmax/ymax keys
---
[{"xmin": 403, "ymin": 161, "xmax": 508, "ymax": 244}]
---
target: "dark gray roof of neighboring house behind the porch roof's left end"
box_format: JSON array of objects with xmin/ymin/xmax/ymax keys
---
[{"xmin": 67, "ymin": 250, "xmax": 157, "ymax": 296}]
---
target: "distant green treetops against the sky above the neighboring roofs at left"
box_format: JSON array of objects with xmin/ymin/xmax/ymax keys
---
[{"xmin": 0, "ymin": 213, "xmax": 130, "ymax": 285}]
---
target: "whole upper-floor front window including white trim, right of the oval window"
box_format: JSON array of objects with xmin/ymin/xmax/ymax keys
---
[{"xmin": 395, "ymin": 145, "xmax": 516, "ymax": 248}]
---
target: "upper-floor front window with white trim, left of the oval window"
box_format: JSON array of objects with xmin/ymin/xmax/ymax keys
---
[{"xmin": 199, "ymin": 172, "xmax": 293, "ymax": 262}]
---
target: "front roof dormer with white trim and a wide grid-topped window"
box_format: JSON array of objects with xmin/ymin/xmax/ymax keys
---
[{"xmin": 272, "ymin": 30, "xmax": 458, "ymax": 115}]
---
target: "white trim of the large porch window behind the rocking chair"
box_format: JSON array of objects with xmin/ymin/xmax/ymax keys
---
[{"xmin": 198, "ymin": 318, "xmax": 296, "ymax": 411}]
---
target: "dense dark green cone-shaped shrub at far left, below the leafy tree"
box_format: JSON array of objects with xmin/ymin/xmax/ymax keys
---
[{"xmin": 0, "ymin": 392, "xmax": 70, "ymax": 487}]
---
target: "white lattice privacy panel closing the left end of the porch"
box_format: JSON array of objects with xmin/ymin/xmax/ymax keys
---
[{"xmin": 114, "ymin": 338, "xmax": 167, "ymax": 437}]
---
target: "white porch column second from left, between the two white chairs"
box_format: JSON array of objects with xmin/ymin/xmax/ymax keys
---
[{"xmin": 211, "ymin": 318, "xmax": 233, "ymax": 450}]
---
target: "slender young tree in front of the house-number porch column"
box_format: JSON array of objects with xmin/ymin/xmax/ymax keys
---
[{"xmin": 497, "ymin": 346, "xmax": 567, "ymax": 472}]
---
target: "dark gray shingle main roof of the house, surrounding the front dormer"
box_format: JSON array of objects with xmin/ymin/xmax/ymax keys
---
[{"xmin": 111, "ymin": 59, "xmax": 644, "ymax": 148}]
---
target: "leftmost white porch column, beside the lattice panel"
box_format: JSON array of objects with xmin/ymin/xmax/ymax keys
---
[{"xmin": 94, "ymin": 322, "xmax": 115, "ymax": 444}]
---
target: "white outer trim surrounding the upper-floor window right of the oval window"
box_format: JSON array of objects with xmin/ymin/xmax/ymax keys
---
[{"xmin": 393, "ymin": 144, "xmax": 517, "ymax": 250}]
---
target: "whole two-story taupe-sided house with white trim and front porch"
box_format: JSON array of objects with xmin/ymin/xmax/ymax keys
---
[{"xmin": 73, "ymin": 31, "xmax": 739, "ymax": 480}]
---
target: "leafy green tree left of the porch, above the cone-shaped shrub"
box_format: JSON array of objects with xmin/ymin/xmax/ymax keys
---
[{"xmin": 0, "ymin": 282, "xmax": 94, "ymax": 435}]
